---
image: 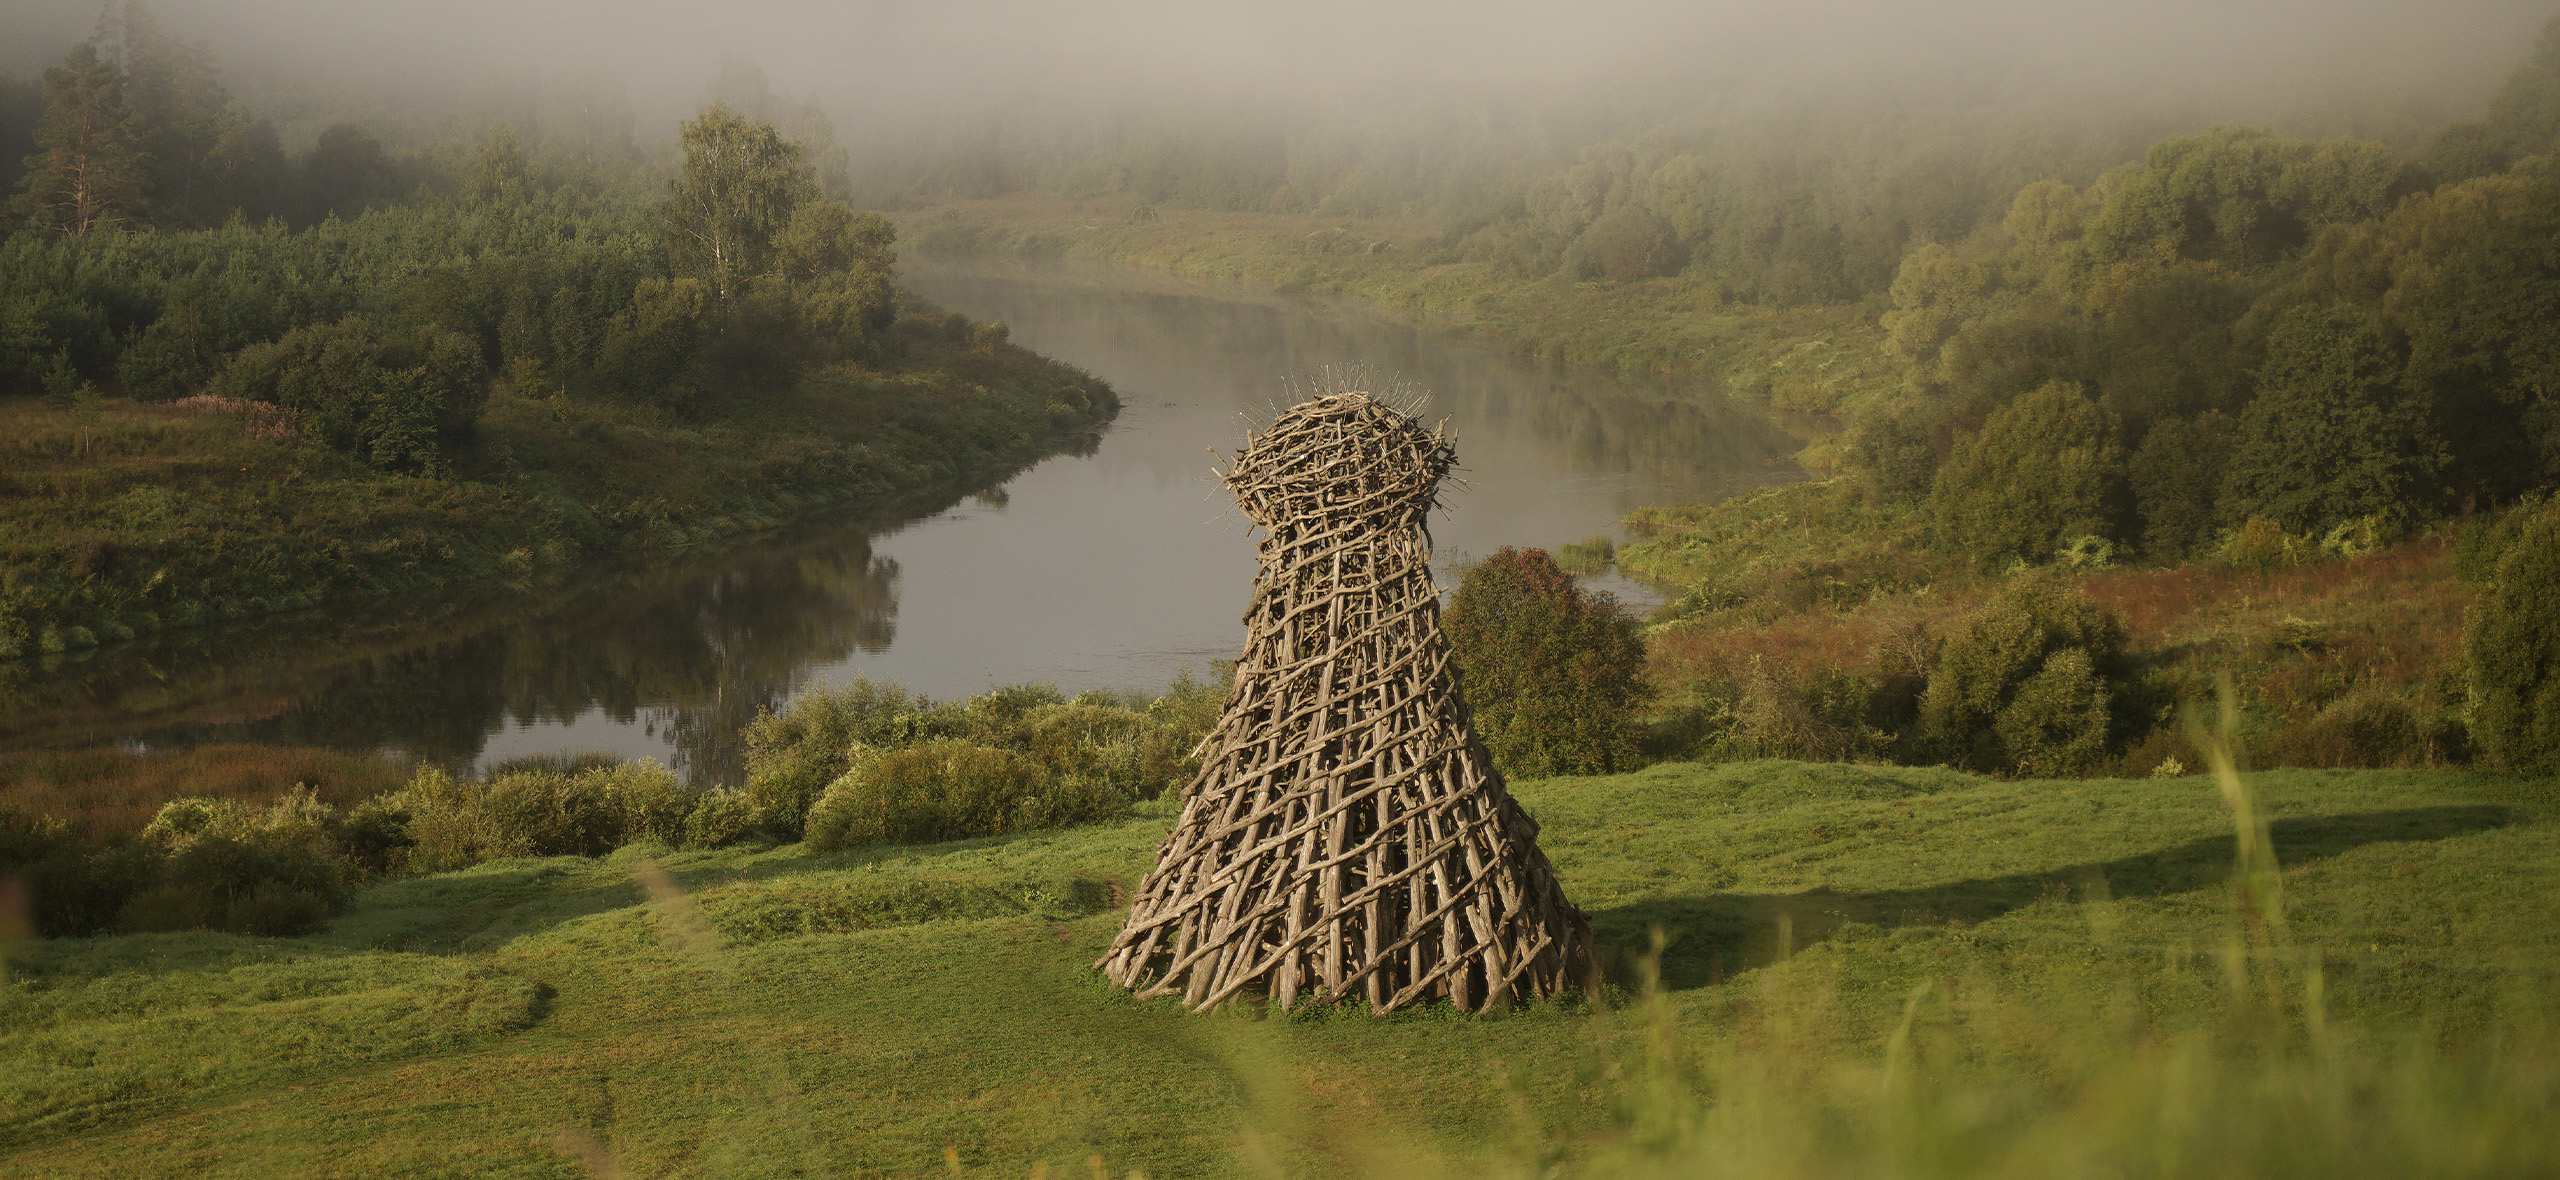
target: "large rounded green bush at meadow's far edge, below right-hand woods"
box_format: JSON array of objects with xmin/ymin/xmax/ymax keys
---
[{"xmin": 1920, "ymin": 576, "xmax": 2125, "ymax": 776}]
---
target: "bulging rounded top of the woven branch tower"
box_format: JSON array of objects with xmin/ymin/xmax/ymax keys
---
[{"xmin": 1224, "ymin": 394, "xmax": 1457, "ymax": 527}]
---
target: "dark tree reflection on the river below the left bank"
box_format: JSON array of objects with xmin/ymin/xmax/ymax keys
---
[{"xmin": 0, "ymin": 497, "xmax": 911, "ymax": 783}]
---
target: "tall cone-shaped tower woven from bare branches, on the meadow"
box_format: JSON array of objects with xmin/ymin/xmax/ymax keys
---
[{"xmin": 1096, "ymin": 394, "xmax": 1592, "ymax": 1011}]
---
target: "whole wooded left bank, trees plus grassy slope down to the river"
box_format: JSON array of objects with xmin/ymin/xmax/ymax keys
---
[{"xmin": 0, "ymin": 3, "xmax": 1116, "ymax": 658}]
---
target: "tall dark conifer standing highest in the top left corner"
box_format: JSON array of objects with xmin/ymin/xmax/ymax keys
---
[{"xmin": 18, "ymin": 41, "xmax": 148, "ymax": 238}]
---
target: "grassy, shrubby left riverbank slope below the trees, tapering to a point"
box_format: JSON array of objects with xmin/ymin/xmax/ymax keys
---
[{"xmin": 0, "ymin": 300, "xmax": 1119, "ymax": 673}]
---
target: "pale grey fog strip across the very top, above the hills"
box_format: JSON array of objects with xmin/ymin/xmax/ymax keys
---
[{"xmin": 0, "ymin": 0, "xmax": 2555, "ymax": 150}]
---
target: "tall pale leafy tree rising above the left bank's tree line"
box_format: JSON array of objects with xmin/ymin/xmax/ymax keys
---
[{"xmin": 666, "ymin": 102, "xmax": 817, "ymax": 302}]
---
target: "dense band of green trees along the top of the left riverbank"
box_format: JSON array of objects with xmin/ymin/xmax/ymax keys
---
[{"xmin": 0, "ymin": 3, "xmax": 896, "ymax": 474}]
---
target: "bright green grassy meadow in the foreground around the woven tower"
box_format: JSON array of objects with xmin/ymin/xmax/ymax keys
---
[{"xmin": 0, "ymin": 763, "xmax": 2560, "ymax": 1177}]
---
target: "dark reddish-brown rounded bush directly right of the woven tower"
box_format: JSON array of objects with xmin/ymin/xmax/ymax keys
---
[{"xmin": 1449, "ymin": 545, "xmax": 1649, "ymax": 776}]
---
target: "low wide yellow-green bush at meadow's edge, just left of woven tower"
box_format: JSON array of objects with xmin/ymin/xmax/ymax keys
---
[{"xmin": 809, "ymin": 737, "xmax": 1129, "ymax": 850}]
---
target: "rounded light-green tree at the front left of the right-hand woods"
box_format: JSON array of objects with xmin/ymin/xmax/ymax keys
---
[{"xmin": 1930, "ymin": 381, "xmax": 2122, "ymax": 566}]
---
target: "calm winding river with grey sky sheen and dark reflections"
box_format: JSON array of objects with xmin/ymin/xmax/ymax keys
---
[{"xmin": 0, "ymin": 264, "xmax": 1802, "ymax": 781}]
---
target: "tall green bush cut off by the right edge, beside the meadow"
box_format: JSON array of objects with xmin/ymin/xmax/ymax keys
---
[{"xmin": 2463, "ymin": 504, "xmax": 2560, "ymax": 776}]
